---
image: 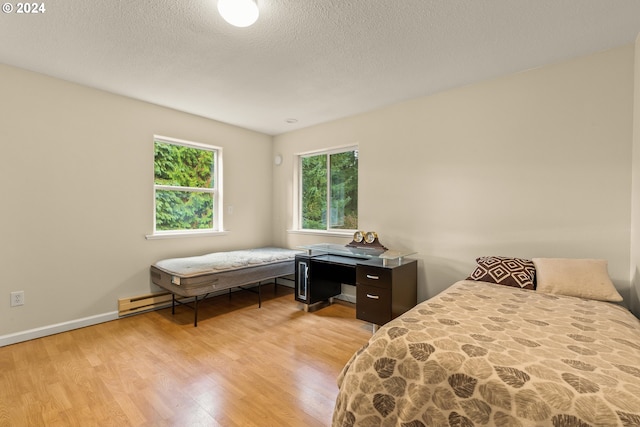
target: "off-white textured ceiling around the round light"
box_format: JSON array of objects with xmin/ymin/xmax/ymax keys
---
[{"xmin": 0, "ymin": 0, "xmax": 640, "ymax": 135}]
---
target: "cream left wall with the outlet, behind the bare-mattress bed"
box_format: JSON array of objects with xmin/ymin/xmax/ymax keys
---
[{"xmin": 0, "ymin": 65, "xmax": 273, "ymax": 338}]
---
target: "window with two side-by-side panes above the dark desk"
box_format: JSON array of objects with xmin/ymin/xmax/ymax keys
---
[{"xmin": 299, "ymin": 147, "xmax": 358, "ymax": 234}]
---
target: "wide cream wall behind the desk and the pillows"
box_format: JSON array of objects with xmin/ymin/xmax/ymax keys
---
[{"xmin": 273, "ymin": 45, "xmax": 634, "ymax": 310}]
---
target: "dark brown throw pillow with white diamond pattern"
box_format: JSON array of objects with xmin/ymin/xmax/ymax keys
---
[{"xmin": 467, "ymin": 256, "xmax": 536, "ymax": 289}]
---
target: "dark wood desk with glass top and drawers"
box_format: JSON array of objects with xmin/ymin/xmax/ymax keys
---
[{"xmin": 295, "ymin": 253, "xmax": 418, "ymax": 326}]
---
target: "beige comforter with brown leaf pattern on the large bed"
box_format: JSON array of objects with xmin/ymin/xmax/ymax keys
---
[{"xmin": 333, "ymin": 280, "xmax": 640, "ymax": 427}]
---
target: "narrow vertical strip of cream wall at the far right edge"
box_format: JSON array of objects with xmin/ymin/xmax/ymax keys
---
[{"xmin": 630, "ymin": 35, "xmax": 640, "ymax": 317}]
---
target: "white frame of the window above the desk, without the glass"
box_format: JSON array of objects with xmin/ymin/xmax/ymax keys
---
[{"xmin": 290, "ymin": 144, "xmax": 360, "ymax": 237}]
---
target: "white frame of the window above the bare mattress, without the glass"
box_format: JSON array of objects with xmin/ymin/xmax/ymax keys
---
[{"xmin": 146, "ymin": 135, "xmax": 226, "ymax": 239}]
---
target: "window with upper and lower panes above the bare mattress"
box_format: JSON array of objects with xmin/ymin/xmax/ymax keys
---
[{"xmin": 154, "ymin": 137, "xmax": 221, "ymax": 234}]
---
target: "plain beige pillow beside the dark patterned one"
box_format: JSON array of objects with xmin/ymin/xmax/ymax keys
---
[{"xmin": 532, "ymin": 258, "xmax": 622, "ymax": 302}]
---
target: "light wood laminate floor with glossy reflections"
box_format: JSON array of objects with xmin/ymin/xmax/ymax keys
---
[{"xmin": 0, "ymin": 285, "xmax": 371, "ymax": 427}]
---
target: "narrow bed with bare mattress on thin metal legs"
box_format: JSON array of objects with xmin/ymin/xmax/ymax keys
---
[{"xmin": 150, "ymin": 247, "xmax": 301, "ymax": 326}]
